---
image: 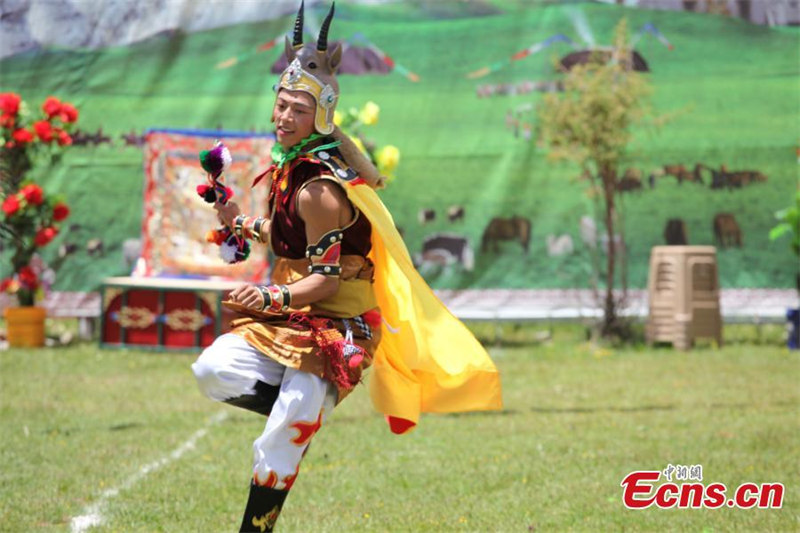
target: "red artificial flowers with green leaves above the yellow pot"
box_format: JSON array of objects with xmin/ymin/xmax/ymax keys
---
[{"xmin": 0, "ymin": 93, "xmax": 78, "ymax": 306}]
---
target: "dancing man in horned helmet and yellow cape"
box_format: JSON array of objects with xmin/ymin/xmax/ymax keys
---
[{"xmin": 192, "ymin": 3, "xmax": 501, "ymax": 531}]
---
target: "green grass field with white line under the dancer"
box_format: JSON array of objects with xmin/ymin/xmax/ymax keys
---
[{"xmin": 0, "ymin": 326, "xmax": 800, "ymax": 532}]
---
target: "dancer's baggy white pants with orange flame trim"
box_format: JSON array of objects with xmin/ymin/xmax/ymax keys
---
[{"xmin": 192, "ymin": 333, "xmax": 337, "ymax": 490}]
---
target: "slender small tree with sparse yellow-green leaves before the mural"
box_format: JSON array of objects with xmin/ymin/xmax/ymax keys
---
[{"xmin": 538, "ymin": 19, "xmax": 651, "ymax": 337}]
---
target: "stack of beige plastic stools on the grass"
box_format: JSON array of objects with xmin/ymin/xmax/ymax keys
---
[{"xmin": 645, "ymin": 246, "xmax": 722, "ymax": 350}]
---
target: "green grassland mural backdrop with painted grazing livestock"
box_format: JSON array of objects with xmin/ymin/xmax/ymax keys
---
[{"xmin": 0, "ymin": 1, "xmax": 800, "ymax": 290}]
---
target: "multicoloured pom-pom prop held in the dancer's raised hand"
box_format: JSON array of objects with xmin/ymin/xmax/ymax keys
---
[{"xmin": 197, "ymin": 141, "xmax": 250, "ymax": 264}]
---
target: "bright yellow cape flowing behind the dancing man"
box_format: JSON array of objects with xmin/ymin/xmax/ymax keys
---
[{"xmin": 345, "ymin": 184, "xmax": 502, "ymax": 433}]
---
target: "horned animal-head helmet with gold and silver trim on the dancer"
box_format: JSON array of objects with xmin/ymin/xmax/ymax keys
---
[{"xmin": 278, "ymin": 1, "xmax": 342, "ymax": 135}]
